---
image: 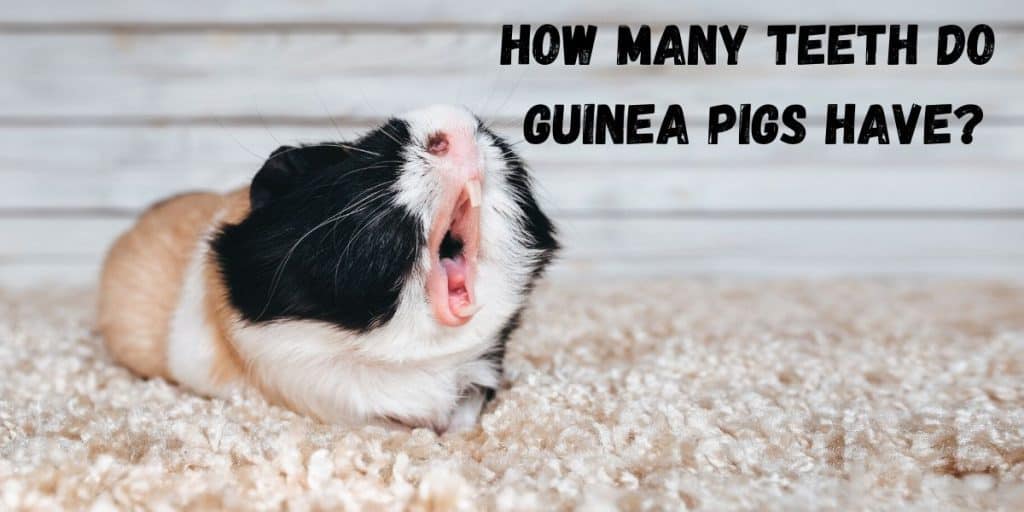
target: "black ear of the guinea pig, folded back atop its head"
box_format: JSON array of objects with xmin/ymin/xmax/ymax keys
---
[{"xmin": 249, "ymin": 144, "xmax": 347, "ymax": 210}]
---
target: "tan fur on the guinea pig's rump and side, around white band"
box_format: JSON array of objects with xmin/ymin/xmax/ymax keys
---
[{"xmin": 99, "ymin": 189, "xmax": 249, "ymax": 382}]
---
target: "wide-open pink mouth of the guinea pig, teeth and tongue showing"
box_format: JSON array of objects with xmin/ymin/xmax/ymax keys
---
[{"xmin": 427, "ymin": 179, "xmax": 480, "ymax": 327}]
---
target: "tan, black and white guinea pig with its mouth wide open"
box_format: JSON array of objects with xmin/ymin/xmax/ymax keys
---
[{"xmin": 98, "ymin": 105, "xmax": 558, "ymax": 432}]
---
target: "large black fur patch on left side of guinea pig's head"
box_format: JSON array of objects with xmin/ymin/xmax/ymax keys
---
[{"xmin": 213, "ymin": 120, "xmax": 426, "ymax": 331}]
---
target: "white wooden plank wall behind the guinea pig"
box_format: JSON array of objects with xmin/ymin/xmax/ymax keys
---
[{"xmin": 0, "ymin": 0, "xmax": 1024, "ymax": 286}]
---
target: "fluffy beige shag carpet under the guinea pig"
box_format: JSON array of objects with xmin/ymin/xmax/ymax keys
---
[{"xmin": 0, "ymin": 281, "xmax": 1024, "ymax": 511}]
